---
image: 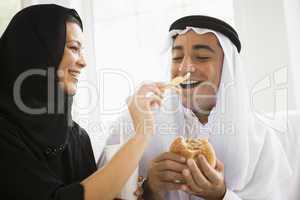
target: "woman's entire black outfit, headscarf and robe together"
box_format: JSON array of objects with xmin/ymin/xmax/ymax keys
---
[{"xmin": 0, "ymin": 5, "xmax": 96, "ymax": 200}]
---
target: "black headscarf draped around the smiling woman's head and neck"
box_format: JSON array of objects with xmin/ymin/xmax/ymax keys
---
[{"xmin": 0, "ymin": 4, "xmax": 82, "ymax": 158}]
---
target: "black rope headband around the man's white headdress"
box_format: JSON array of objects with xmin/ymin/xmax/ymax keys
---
[{"xmin": 169, "ymin": 15, "xmax": 241, "ymax": 52}]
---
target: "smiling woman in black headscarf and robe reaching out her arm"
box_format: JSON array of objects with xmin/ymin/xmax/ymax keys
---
[{"xmin": 0, "ymin": 5, "xmax": 163, "ymax": 200}]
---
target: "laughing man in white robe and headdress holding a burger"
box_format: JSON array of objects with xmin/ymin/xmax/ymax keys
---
[{"xmin": 98, "ymin": 16, "xmax": 290, "ymax": 200}]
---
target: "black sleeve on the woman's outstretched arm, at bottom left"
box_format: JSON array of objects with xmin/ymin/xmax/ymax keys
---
[{"xmin": 0, "ymin": 130, "xmax": 84, "ymax": 200}]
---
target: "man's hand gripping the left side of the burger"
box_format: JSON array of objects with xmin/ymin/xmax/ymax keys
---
[{"xmin": 148, "ymin": 152, "xmax": 187, "ymax": 199}]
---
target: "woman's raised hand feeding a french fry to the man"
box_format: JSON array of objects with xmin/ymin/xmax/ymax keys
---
[{"xmin": 128, "ymin": 83, "xmax": 165, "ymax": 136}]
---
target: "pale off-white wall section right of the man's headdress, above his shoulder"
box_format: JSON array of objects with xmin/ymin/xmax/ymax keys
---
[{"xmin": 234, "ymin": 0, "xmax": 295, "ymax": 118}]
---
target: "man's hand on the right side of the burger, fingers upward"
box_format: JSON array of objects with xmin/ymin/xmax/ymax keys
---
[{"xmin": 181, "ymin": 155, "xmax": 226, "ymax": 200}]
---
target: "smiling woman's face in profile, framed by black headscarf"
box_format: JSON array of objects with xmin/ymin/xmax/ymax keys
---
[{"xmin": 57, "ymin": 22, "xmax": 86, "ymax": 95}]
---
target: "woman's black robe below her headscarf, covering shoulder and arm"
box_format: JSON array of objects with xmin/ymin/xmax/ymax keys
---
[{"xmin": 0, "ymin": 118, "xmax": 97, "ymax": 200}]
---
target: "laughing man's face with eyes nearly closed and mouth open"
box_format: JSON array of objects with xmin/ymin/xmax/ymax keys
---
[{"xmin": 171, "ymin": 31, "xmax": 224, "ymax": 114}]
